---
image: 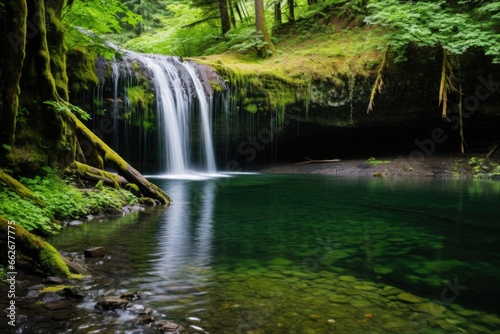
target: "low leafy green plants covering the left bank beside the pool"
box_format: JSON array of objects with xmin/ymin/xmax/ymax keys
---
[{"xmin": 0, "ymin": 167, "xmax": 138, "ymax": 233}]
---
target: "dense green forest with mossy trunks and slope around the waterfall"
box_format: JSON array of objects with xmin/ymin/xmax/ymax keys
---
[{"xmin": 0, "ymin": 0, "xmax": 500, "ymax": 284}]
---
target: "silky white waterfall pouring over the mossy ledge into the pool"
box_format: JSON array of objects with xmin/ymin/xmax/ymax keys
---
[{"xmin": 112, "ymin": 52, "xmax": 217, "ymax": 175}]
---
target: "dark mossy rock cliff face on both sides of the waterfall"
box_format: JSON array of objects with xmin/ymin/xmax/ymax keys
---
[{"xmin": 74, "ymin": 51, "xmax": 500, "ymax": 170}]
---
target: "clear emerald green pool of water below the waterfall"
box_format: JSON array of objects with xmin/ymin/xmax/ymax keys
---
[{"xmin": 50, "ymin": 175, "xmax": 500, "ymax": 334}]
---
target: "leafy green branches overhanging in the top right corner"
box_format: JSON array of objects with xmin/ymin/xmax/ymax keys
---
[{"xmin": 365, "ymin": 0, "xmax": 500, "ymax": 62}]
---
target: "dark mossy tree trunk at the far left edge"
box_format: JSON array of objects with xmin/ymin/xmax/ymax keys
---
[{"xmin": 0, "ymin": 0, "xmax": 28, "ymax": 165}]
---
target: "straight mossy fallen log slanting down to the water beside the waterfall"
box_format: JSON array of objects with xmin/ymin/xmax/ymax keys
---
[{"xmin": 66, "ymin": 110, "xmax": 172, "ymax": 204}]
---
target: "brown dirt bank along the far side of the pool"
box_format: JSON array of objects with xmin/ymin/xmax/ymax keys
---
[{"xmin": 260, "ymin": 152, "xmax": 500, "ymax": 177}]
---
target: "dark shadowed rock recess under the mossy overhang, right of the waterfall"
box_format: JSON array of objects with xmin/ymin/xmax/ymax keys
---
[{"xmin": 212, "ymin": 54, "xmax": 500, "ymax": 166}]
